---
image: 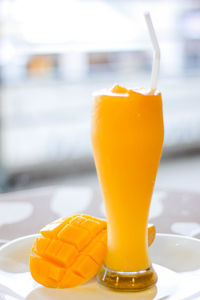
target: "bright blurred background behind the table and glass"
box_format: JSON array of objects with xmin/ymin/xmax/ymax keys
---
[{"xmin": 0, "ymin": 0, "xmax": 200, "ymax": 192}]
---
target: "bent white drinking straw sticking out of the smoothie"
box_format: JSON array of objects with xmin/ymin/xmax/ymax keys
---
[{"xmin": 144, "ymin": 12, "xmax": 160, "ymax": 91}]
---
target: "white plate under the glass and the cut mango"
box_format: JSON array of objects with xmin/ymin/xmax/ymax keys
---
[{"xmin": 0, "ymin": 234, "xmax": 200, "ymax": 300}]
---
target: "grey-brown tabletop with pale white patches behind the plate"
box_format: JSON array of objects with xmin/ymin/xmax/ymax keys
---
[{"xmin": 0, "ymin": 186, "xmax": 200, "ymax": 244}]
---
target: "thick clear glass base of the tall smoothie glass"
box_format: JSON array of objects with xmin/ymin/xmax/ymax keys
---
[{"xmin": 97, "ymin": 265, "xmax": 157, "ymax": 292}]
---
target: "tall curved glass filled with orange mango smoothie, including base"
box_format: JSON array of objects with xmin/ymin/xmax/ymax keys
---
[{"xmin": 91, "ymin": 86, "xmax": 164, "ymax": 291}]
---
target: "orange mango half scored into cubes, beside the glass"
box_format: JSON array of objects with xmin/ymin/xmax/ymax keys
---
[{"xmin": 30, "ymin": 215, "xmax": 156, "ymax": 288}]
